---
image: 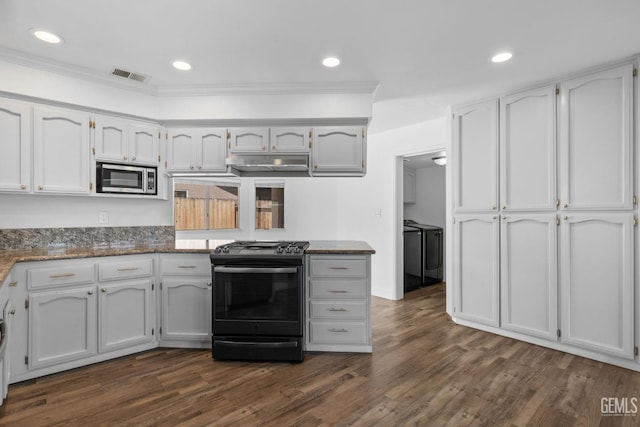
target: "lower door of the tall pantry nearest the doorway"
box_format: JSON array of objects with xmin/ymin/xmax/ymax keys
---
[{"xmin": 454, "ymin": 215, "xmax": 499, "ymax": 326}]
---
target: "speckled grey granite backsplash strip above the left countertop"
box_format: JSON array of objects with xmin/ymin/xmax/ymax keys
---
[{"xmin": 0, "ymin": 226, "xmax": 175, "ymax": 250}]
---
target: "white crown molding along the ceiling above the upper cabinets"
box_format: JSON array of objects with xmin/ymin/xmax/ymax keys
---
[{"xmin": 0, "ymin": 46, "xmax": 379, "ymax": 97}]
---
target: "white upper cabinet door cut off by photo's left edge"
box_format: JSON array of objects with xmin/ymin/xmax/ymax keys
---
[{"xmin": 0, "ymin": 99, "xmax": 31, "ymax": 192}]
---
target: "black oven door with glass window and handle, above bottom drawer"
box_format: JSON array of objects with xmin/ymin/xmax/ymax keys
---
[{"xmin": 212, "ymin": 265, "xmax": 304, "ymax": 337}]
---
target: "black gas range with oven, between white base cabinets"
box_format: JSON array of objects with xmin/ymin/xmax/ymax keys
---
[{"xmin": 211, "ymin": 241, "xmax": 309, "ymax": 362}]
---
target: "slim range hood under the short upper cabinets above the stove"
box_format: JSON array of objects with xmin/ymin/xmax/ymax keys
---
[{"xmin": 225, "ymin": 154, "xmax": 309, "ymax": 176}]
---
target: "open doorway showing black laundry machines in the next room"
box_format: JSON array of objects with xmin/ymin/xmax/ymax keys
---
[{"xmin": 396, "ymin": 150, "xmax": 447, "ymax": 295}]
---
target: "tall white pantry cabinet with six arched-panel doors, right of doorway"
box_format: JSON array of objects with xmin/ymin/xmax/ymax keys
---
[{"xmin": 452, "ymin": 64, "xmax": 637, "ymax": 366}]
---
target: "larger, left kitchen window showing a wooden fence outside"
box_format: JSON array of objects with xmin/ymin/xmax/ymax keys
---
[{"xmin": 173, "ymin": 179, "xmax": 240, "ymax": 231}]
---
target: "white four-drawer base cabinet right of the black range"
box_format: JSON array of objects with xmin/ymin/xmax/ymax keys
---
[{"xmin": 305, "ymin": 254, "xmax": 372, "ymax": 353}]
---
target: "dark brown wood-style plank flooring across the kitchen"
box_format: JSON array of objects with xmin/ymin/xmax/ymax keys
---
[{"xmin": 0, "ymin": 285, "xmax": 640, "ymax": 427}]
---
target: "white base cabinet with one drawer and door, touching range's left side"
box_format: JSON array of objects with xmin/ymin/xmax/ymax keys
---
[{"xmin": 160, "ymin": 254, "xmax": 211, "ymax": 347}]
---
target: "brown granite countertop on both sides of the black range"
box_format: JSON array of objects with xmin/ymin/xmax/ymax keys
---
[{"xmin": 0, "ymin": 240, "xmax": 375, "ymax": 286}]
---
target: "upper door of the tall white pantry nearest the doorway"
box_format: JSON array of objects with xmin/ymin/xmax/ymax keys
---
[{"xmin": 453, "ymin": 100, "xmax": 498, "ymax": 212}]
